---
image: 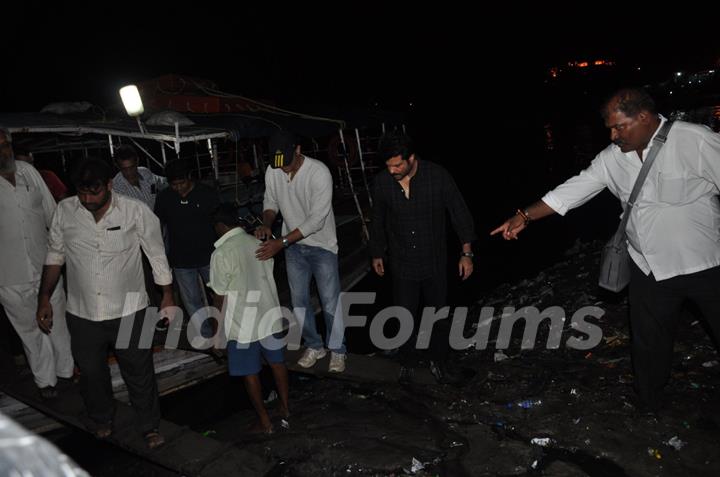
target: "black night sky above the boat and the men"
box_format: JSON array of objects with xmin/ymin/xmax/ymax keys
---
[{"xmin": 5, "ymin": 1, "xmax": 720, "ymax": 114}]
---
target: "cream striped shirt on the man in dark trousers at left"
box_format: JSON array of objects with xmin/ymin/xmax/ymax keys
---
[{"xmin": 45, "ymin": 194, "xmax": 172, "ymax": 321}]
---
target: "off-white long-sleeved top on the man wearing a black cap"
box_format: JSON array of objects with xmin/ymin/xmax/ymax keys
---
[{"xmin": 263, "ymin": 156, "xmax": 338, "ymax": 254}]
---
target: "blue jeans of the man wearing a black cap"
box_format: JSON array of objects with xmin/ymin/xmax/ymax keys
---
[{"xmin": 285, "ymin": 243, "xmax": 345, "ymax": 354}]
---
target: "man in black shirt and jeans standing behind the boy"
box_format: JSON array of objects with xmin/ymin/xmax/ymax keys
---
[{"xmin": 155, "ymin": 159, "xmax": 220, "ymax": 338}]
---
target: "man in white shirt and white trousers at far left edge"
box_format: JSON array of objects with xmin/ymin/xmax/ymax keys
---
[{"xmin": 0, "ymin": 129, "xmax": 73, "ymax": 398}]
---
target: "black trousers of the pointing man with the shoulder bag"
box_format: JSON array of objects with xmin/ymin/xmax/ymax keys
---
[{"xmin": 630, "ymin": 263, "xmax": 720, "ymax": 408}]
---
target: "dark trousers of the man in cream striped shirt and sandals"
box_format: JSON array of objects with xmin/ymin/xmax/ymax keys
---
[{"xmin": 67, "ymin": 309, "xmax": 160, "ymax": 433}]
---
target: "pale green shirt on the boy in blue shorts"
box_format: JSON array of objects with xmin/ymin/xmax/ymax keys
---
[{"xmin": 208, "ymin": 227, "xmax": 283, "ymax": 343}]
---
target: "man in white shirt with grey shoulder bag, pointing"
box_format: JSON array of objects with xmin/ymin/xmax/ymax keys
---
[{"xmin": 491, "ymin": 89, "xmax": 720, "ymax": 411}]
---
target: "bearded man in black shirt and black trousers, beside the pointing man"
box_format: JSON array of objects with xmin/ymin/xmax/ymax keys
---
[{"xmin": 370, "ymin": 133, "xmax": 476, "ymax": 382}]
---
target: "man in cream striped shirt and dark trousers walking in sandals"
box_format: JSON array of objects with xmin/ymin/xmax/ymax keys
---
[{"xmin": 37, "ymin": 160, "xmax": 173, "ymax": 448}]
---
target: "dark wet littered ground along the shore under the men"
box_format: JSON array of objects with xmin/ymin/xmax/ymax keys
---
[{"xmin": 50, "ymin": 242, "xmax": 720, "ymax": 476}]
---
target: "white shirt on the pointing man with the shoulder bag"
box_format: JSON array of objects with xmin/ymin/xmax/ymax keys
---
[{"xmin": 542, "ymin": 117, "xmax": 720, "ymax": 280}]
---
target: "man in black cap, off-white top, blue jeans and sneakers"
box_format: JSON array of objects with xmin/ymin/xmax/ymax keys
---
[{"xmin": 255, "ymin": 131, "xmax": 346, "ymax": 373}]
